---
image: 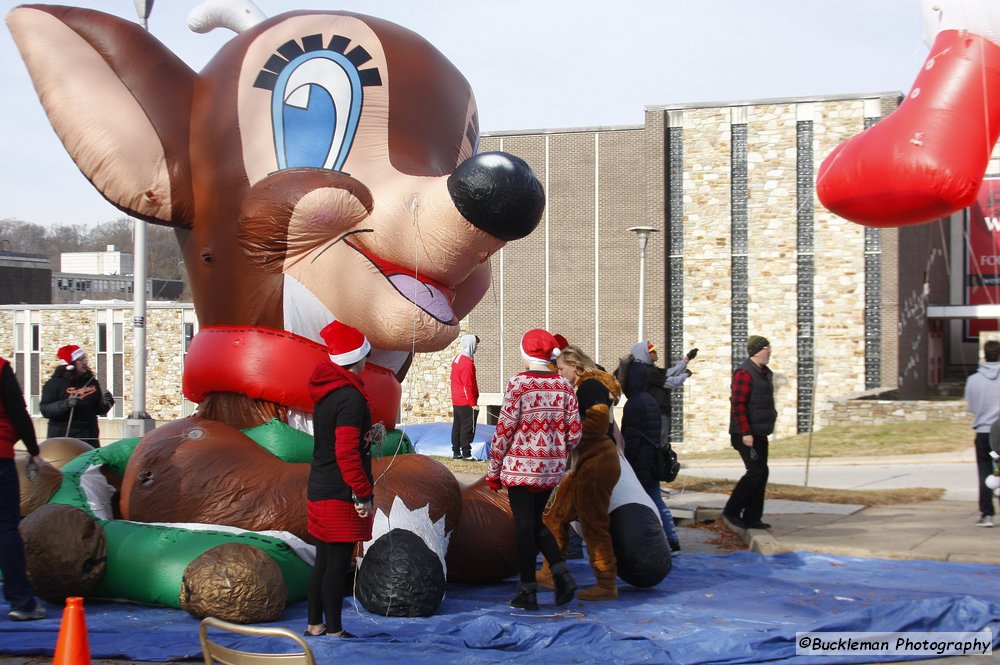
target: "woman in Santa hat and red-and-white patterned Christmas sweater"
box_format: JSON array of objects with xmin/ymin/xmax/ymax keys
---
[{"xmin": 486, "ymin": 328, "xmax": 582, "ymax": 610}]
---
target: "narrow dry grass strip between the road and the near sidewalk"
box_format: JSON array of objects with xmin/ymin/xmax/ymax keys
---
[{"xmin": 670, "ymin": 473, "xmax": 944, "ymax": 506}]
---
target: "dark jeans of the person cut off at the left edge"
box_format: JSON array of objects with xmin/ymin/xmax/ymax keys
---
[{"xmin": 0, "ymin": 459, "xmax": 35, "ymax": 611}]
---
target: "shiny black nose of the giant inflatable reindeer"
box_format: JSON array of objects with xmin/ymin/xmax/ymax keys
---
[{"xmin": 448, "ymin": 152, "xmax": 545, "ymax": 240}]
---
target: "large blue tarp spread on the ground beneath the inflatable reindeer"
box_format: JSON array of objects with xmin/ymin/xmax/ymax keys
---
[{"xmin": 0, "ymin": 552, "xmax": 1000, "ymax": 665}]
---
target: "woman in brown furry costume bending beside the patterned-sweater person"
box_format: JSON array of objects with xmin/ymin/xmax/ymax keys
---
[{"xmin": 537, "ymin": 346, "xmax": 621, "ymax": 600}]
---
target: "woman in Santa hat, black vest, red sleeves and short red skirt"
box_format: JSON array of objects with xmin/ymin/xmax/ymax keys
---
[{"xmin": 304, "ymin": 321, "xmax": 374, "ymax": 637}]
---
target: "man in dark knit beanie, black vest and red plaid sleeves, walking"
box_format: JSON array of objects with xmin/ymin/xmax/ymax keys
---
[{"xmin": 722, "ymin": 335, "xmax": 778, "ymax": 530}]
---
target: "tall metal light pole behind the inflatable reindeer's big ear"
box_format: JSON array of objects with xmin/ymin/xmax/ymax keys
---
[{"xmin": 123, "ymin": 0, "xmax": 156, "ymax": 438}]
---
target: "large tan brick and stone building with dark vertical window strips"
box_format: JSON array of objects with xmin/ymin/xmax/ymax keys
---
[{"xmin": 404, "ymin": 93, "xmax": 968, "ymax": 447}]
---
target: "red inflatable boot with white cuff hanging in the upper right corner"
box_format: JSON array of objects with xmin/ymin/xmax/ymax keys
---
[{"xmin": 816, "ymin": 0, "xmax": 1000, "ymax": 226}]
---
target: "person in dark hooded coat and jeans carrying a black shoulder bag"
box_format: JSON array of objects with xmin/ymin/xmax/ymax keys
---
[{"xmin": 622, "ymin": 341, "xmax": 681, "ymax": 553}]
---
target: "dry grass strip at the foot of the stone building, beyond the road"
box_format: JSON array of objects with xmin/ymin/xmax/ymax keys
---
[{"xmin": 676, "ymin": 415, "xmax": 974, "ymax": 463}]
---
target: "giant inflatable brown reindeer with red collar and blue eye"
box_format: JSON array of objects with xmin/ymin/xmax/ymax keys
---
[{"xmin": 7, "ymin": 0, "xmax": 544, "ymax": 621}]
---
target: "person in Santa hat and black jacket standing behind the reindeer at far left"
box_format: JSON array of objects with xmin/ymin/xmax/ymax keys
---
[{"xmin": 40, "ymin": 344, "xmax": 115, "ymax": 448}]
